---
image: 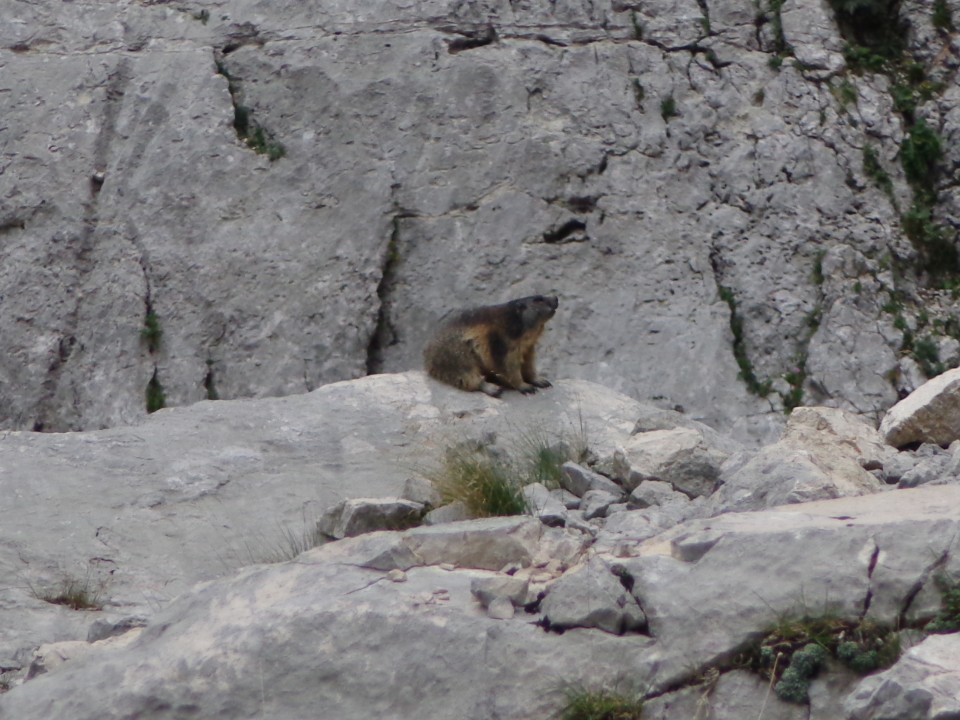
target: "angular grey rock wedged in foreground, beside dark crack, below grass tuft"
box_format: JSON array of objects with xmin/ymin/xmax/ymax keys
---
[{"xmin": 540, "ymin": 561, "xmax": 646, "ymax": 635}]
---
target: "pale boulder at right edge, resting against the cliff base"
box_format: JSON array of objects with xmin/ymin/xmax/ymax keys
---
[{"xmin": 880, "ymin": 368, "xmax": 960, "ymax": 448}]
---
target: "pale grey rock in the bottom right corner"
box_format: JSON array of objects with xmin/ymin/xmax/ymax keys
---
[{"xmin": 844, "ymin": 634, "xmax": 960, "ymax": 720}]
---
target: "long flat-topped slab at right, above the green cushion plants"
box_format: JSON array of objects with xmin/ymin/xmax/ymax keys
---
[{"xmin": 618, "ymin": 485, "xmax": 960, "ymax": 680}]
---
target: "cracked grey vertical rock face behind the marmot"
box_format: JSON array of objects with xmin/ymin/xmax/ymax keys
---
[{"xmin": 0, "ymin": 0, "xmax": 960, "ymax": 440}]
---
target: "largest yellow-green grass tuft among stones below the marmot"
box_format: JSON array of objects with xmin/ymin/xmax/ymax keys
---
[{"xmin": 432, "ymin": 445, "xmax": 527, "ymax": 517}]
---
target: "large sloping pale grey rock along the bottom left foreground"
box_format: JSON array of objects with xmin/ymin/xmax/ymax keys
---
[{"xmin": 0, "ymin": 544, "xmax": 655, "ymax": 720}]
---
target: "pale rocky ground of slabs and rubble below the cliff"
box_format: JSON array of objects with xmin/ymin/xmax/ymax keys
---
[{"xmin": 0, "ymin": 371, "xmax": 960, "ymax": 720}]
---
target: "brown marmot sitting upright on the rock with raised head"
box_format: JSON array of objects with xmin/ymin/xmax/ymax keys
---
[{"xmin": 423, "ymin": 295, "xmax": 559, "ymax": 397}]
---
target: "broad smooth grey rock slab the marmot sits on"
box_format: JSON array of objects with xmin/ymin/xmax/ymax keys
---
[{"xmin": 0, "ymin": 372, "xmax": 656, "ymax": 662}]
